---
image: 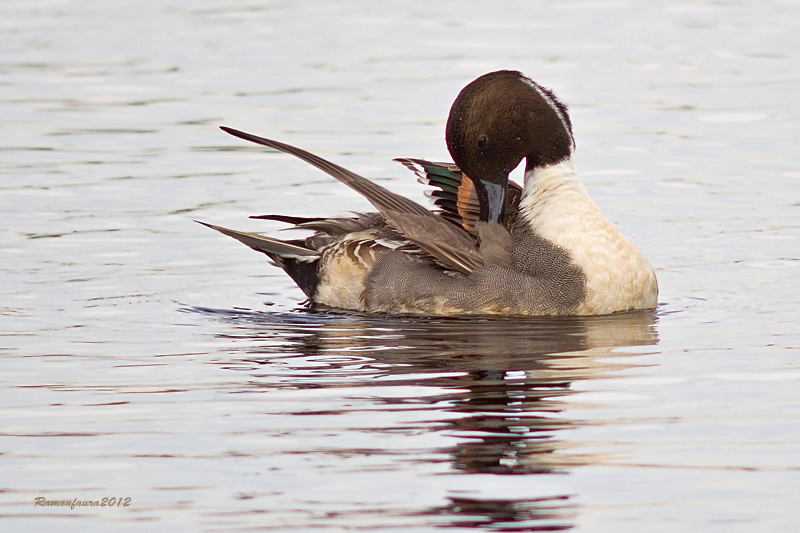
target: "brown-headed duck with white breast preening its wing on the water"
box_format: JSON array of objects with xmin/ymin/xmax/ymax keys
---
[{"xmin": 198, "ymin": 70, "xmax": 658, "ymax": 317}]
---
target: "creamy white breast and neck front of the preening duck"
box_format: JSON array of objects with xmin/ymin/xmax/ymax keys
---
[{"xmin": 520, "ymin": 159, "xmax": 658, "ymax": 315}]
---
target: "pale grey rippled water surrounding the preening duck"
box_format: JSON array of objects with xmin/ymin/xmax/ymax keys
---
[{"xmin": 0, "ymin": 0, "xmax": 800, "ymax": 532}]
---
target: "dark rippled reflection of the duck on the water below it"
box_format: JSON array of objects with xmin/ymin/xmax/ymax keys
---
[{"xmin": 186, "ymin": 308, "xmax": 658, "ymax": 531}]
